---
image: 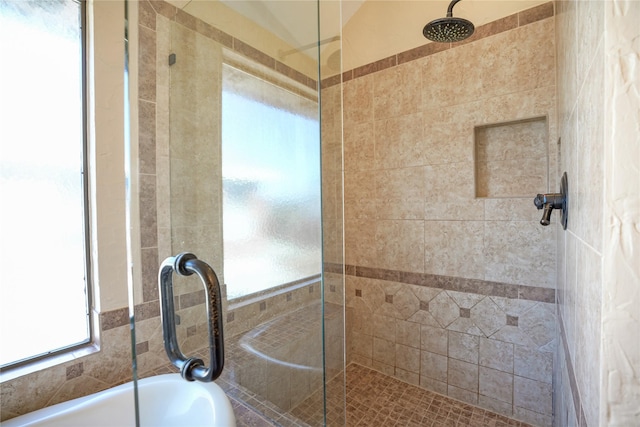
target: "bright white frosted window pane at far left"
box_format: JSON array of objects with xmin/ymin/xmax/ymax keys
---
[{"xmin": 0, "ymin": 0, "xmax": 90, "ymax": 366}]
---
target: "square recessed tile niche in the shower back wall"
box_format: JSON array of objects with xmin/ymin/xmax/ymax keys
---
[{"xmin": 474, "ymin": 117, "xmax": 549, "ymax": 198}]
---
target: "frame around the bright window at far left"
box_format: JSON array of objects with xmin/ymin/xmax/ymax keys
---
[{"xmin": 0, "ymin": 0, "xmax": 98, "ymax": 372}]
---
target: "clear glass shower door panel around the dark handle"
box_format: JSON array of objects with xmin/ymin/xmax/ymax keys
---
[{"xmin": 126, "ymin": 1, "xmax": 344, "ymax": 425}]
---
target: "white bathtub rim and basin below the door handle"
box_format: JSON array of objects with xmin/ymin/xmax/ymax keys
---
[{"xmin": 2, "ymin": 374, "xmax": 236, "ymax": 427}]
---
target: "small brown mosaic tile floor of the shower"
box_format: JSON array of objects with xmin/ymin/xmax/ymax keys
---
[{"xmin": 221, "ymin": 364, "xmax": 531, "ymax": 427}]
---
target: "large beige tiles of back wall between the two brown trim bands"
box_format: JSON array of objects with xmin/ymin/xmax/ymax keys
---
[{"xmin": 344, "ymin": 20, "xmax": 556, "ymax": 288}]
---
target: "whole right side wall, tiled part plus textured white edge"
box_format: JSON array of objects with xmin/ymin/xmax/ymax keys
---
[{"xmin": 554, "ymin": 1, "xmax": 640, "ymax": 426}]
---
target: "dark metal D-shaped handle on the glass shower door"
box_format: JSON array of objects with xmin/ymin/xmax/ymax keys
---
[{"xmin": 158, "ymin": 252, "xmax": 224, "ymax": 382}]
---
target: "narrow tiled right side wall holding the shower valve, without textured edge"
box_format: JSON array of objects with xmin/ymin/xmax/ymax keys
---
[{"xmin": 555, "ymin": 1, "xmax": 604, "ymax": 426}]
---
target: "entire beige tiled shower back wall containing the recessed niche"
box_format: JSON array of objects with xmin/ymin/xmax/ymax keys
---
[{"xmin": 326, "ymin": 3, "xmax": 557, "ymax": 426}]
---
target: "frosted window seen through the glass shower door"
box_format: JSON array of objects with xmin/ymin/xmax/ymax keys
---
[{"xmin": 222, "ymin": 65, "xmax": 321, "ymax": 298}]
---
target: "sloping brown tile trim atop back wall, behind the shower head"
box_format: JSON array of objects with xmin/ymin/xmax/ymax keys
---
[{"xmin": 321, "ymin": 2, "xmax": 554, "ymax": 88}]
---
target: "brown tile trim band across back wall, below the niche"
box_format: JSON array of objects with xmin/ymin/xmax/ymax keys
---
[{"xmin": 342, "ymin": 264, "xmax": 556, "ymax": 303}]
